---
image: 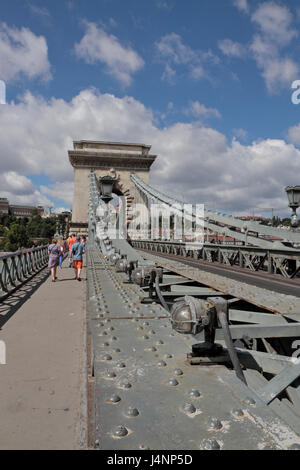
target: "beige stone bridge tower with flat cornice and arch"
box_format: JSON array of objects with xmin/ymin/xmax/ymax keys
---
[{"xmin": 68, "ymin": 140, "xmax": 156, "ymax": 233}]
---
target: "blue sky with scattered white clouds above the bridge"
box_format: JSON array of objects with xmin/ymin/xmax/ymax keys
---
[{"xmin": 0, "ymin": 0, "xmax": 300, "ymax": 214}]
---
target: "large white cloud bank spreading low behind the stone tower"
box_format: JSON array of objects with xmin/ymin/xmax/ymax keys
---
[{"xmin": 0, "ymin": 89, "xmax": 300, "ymax": 213}]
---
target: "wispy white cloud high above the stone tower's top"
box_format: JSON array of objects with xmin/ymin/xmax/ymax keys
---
[{"xmin": 75, "ymin": 22, "xmax": 144, "ymax": 85}]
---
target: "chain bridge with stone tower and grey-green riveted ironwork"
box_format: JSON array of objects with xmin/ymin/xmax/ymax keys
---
[{"xmin": 0, "ymin": 141, "xmax": 300, "ymax": 450}]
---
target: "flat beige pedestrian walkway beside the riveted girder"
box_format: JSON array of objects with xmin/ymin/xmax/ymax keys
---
[{"xmin": 0, "ymin": 260, "xmax": 86, "ymax": 449}]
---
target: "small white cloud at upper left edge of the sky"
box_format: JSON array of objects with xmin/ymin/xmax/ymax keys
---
[{"xmin": 0, "ymin": 23, "xmax": 51, "ymax": 82}]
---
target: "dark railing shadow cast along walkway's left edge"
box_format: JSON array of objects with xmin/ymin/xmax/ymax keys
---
[{"xmin": 0, "ymin": 267, "xmax": 50, "ymax": 329}]
